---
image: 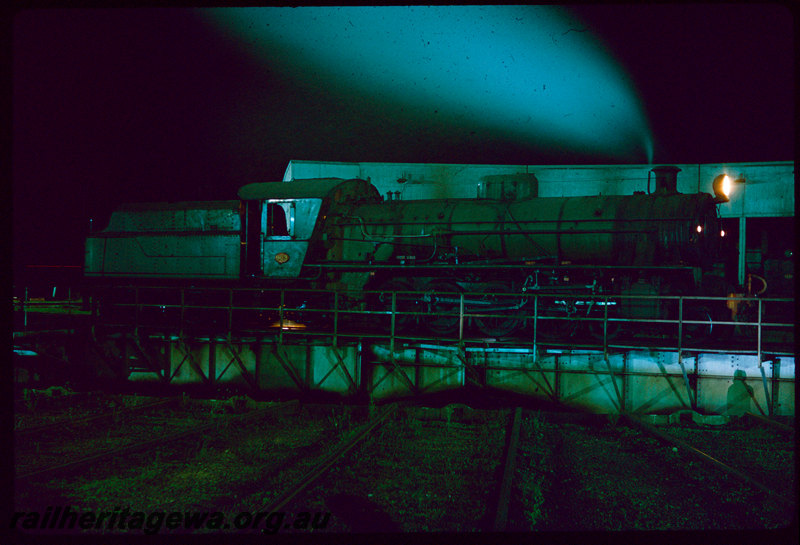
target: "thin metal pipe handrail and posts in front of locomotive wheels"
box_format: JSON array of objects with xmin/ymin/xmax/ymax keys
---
[{"xmin": 92, "ymin": 280, "xmax": 794, "ymax": 361}]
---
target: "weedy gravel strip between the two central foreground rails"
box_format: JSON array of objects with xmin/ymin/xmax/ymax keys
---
[{"xmin": 282, "ymin": 411, "xmax": 508, "ymax": 532}]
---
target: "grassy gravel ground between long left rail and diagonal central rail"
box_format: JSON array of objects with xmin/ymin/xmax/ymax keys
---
[{"xmin": 15, "ymin": 400, "xmax": 368, "ymax": 532}]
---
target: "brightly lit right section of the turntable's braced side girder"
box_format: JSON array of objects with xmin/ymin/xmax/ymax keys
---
[{"xmin": 364, "ymin": 346, "xmax": 795, "ymax": 416}]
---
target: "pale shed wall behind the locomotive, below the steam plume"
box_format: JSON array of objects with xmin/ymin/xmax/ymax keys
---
[{"xmin": 284, "ymin": 160, "xmax": 794, "ymax": 217}]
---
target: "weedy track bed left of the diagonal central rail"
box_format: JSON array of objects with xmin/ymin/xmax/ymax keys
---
[{"xmin": 15, "ymin": 401, "xmax": 376, "ymax": 531}]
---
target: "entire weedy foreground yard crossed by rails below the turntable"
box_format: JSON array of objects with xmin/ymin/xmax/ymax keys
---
[{"xmin": 16, "ymin": 398, "xmax": 795, "ymax": 532}]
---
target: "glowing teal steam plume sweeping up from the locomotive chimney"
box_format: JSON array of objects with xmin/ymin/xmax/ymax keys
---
[{"xmin": 204, "ymin": 6, "xmax": 652, "ymax": 162}]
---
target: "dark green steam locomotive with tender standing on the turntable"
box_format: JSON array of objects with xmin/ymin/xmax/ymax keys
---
[{"xmin": 85, "ymin": 166, "xmax": 720, "ymax": 335}]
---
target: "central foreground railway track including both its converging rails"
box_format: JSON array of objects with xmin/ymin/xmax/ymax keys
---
[{"xmin": 261, "ymin": 406, "xmax": 522, "ymax": 533}]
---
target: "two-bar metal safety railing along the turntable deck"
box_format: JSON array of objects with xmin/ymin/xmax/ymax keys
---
[{"xmin": 86, "ymin": 286, "xmax": 794, "ymax": 361}]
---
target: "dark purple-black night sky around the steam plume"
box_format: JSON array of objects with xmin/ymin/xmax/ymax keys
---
[{"xmin": 12, "ymin": 4, "xmax": 794, "ymax": 272}]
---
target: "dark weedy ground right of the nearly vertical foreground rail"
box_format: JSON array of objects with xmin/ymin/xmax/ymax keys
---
[{"xmin": 509, "ymin": 410, "xmax": 795, "ymax": 531}]
